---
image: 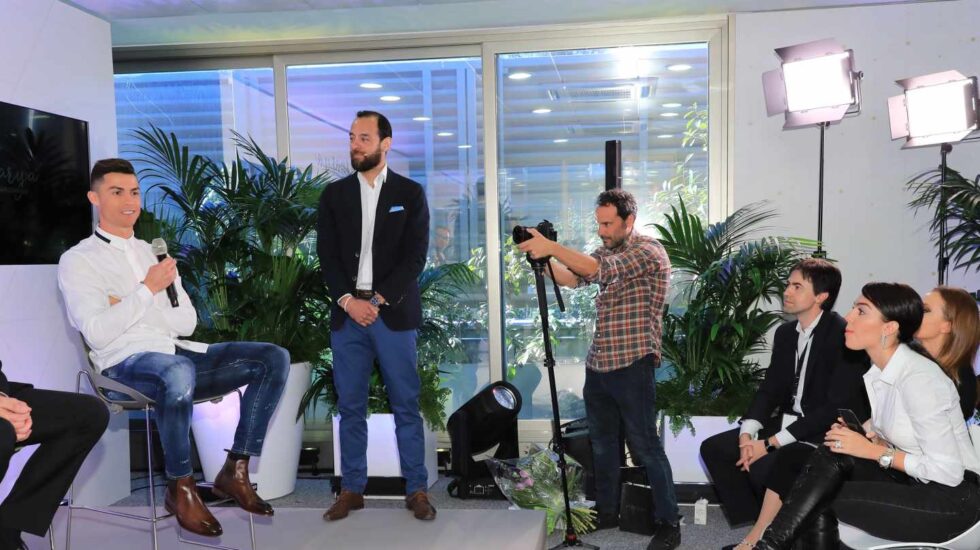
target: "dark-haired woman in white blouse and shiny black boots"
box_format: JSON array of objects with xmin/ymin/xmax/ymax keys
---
[{"xmin": 755, "ymin": 283, "xmax": 980, "ymax": 549}]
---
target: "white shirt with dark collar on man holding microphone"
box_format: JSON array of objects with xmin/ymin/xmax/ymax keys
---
[{"xmin": 58, "ymin": 229, "xmax": 207, "ymax": 371}]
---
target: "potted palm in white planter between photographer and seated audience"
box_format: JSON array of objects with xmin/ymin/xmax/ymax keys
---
[{"xmin": 655, "ymin": 200, "xmax": 815, "ymax": 482}]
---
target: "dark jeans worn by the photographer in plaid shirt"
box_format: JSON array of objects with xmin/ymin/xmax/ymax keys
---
[{"xmin": 582, "ymin": 358, "xmax": 678, "ymax": 523}]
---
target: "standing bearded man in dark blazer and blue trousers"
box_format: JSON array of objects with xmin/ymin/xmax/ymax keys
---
[{"xmin": 317, "ymin": 111, "xmax": 436, "ymax": 520}]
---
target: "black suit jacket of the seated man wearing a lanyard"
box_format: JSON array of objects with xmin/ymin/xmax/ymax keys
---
[{"xmin": 745, "ymin": 311, "xmax": 871, "ymax": 443}]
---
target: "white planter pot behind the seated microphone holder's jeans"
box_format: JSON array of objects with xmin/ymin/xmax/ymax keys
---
[{"xmin": 191, "ymin": 363, "xmax": 311, "ymax": 499}]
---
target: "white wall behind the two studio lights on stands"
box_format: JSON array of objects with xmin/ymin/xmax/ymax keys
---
[{"xmin": 733, "ymin": 0, "xmax": 980, "ymax": 311}]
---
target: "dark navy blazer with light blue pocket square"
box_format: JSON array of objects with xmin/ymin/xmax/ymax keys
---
[{"xmin": 316, "ymin": 168, "xmax": 429, "ymax": 330}]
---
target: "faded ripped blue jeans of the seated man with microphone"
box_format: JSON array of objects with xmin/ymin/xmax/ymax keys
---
[{"xmin": 108, "ymin": 342, "xmax": 289, "ymax": 479}]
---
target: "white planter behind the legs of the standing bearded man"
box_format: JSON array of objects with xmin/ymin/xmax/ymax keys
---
[{"xmin": 333, "ymin": 414, "xmax": 439, "ymax": 487}]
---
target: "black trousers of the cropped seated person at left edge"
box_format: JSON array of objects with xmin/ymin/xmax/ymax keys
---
[{"xmin": 0, "ymin": 388, "xmax": 109, "ymax": 536}]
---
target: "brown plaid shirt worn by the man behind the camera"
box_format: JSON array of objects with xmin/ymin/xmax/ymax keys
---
[{"xmin": 583, "ymin": 230, "xmax": 670, "ymax": 378}]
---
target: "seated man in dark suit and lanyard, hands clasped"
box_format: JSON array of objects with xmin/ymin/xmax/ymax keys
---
[{"xmin": 701, "ymin": 258, "xmax": 869, "ymax": 540}]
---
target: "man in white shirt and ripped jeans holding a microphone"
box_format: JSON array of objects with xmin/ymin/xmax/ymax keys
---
[{"xmin": 58, "ymin": 159, "xmax": 289, "ymax": 537}]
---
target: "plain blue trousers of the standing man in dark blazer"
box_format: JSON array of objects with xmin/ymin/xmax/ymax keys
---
[{"xmin": 331, "ymin": 317, "xmax": 428, "ymax": 494}]
